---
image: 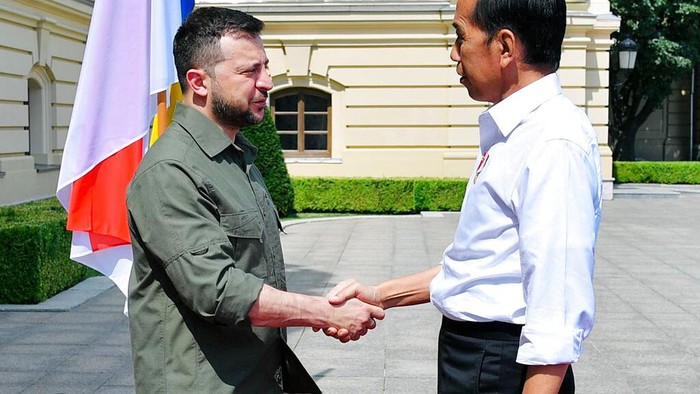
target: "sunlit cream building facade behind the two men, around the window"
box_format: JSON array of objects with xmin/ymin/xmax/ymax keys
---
[{"xmin": 217, "ymin": 0, "xmax": 619, "ymax": 197}]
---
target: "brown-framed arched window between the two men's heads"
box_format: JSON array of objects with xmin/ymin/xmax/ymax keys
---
[{"xmin": 270, "ymin": 88, "xmax": 331, "ymax": 157}]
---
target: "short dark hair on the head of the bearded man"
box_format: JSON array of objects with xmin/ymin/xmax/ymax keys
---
[{"xmin": 173, "ymin": 7, "xmax": 265, "ymax": 92}]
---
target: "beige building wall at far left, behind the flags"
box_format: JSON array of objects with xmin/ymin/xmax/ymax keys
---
[{"xmin": 0, "ymin": 0, "xmax": 92, "ymax": 205}]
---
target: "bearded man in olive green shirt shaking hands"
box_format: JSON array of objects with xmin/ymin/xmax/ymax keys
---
[{"xmin": 127, "ymin": 8, "xmax": 384, "ymax": 393}]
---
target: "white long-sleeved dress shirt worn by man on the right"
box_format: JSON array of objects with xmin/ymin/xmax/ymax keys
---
[{"xmin": 430, "ymin": 74, "xmax": 602, "ymax": 365}]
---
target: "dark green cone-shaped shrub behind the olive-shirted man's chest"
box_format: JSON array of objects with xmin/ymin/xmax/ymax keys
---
[{"xmin": 242, "ymin": 108, "xmax": 294, "ymax": 217}]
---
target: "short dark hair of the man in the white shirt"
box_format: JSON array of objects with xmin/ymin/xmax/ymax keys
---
[{"xmin": 472, "ymin": 0, "xmax": 566, "ymax": 72}]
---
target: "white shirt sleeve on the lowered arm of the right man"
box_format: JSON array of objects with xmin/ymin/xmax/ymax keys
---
[{"xmin": 516, "ymin": 140, "xmax": 600, "ymax": 365}]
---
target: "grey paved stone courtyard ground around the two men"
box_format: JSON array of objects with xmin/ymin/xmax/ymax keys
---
[{"xmin": 0, "ymin": 188, "xmax": 700, "ymax": 394}]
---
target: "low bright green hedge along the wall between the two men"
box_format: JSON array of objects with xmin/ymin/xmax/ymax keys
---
[{"xmin": 292, "ymin": 178, "xmax": 467, "ymax": 214}]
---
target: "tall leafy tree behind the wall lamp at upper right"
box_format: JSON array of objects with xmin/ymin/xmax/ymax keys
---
[{"xmin": 610, "ymin": 0, "xmax": 700, "ymax": 161}]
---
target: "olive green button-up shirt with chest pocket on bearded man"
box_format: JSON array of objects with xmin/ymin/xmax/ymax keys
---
[{"xmin": 127, "ymin": 104, "xmax": 305, "ymax": 393}]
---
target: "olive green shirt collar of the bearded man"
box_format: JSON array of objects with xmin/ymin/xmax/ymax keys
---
[{"xmin": 173, "ymin": 103, "xmax": 258, "ymax": 164}]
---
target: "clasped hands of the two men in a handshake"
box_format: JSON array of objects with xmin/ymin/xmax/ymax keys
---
[{"xmin": 313, "ymin": 279, "xmax": 384, "ymax": 343}]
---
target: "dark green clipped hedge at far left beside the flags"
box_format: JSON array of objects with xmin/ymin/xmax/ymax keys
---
[{"xmin": 0, "ymin": 199, "xmax": 89, "ymax": 304}]
